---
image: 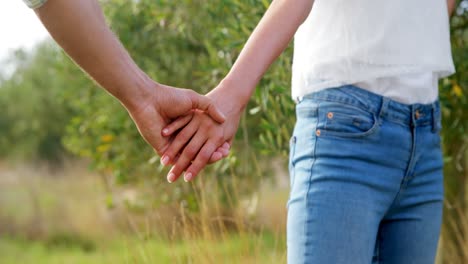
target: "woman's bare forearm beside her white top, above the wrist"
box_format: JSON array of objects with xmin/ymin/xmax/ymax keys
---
[{"xmin": 222, "ymin": 0, "xmax": 313, "ymax": 109}]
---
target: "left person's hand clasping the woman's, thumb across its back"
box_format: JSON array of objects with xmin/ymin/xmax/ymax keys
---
[{"xmin": 127, "ymin": 82, "xmax": 227, "ymax": 157}]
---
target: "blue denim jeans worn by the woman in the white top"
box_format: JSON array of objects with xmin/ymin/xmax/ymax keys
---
[{"xmin": 287, "ymin": 86, "xmax": 444, "ymax": 264}]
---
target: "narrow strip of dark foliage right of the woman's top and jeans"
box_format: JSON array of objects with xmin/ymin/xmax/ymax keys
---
[{"xmin": 440, "ymin": 0, "xmax": 468, "ymax": 263}]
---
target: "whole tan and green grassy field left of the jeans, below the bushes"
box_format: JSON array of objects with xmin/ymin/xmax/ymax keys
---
[{"xmin": 0, "ymin": 163, "xmax": 288, "ymax": 264}]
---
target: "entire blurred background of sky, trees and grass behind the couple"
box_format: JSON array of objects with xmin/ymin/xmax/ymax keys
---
[{"xmin": 0, "ymin": 0, "xmax": 468, "ymax": 264}]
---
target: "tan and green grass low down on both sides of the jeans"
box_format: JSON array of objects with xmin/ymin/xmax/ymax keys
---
[{"xmin": 0, "ymin": 162, "xmax": 468, "ymax": 264}]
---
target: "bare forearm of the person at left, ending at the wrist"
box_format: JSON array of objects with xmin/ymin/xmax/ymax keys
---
[{"xmin": 36, "ymin": 0, "xmax": 154, "ymax": 108}]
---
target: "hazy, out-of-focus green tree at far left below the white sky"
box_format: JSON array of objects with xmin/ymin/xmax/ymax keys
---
[{"xmin": 0, "ymin": 42, "xmax": 72, "ymax": 162}]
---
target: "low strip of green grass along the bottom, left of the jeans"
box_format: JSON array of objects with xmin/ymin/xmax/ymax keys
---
[{"xmin": 0, "ymin": 233, "xmax": 286, "ymax": 264}]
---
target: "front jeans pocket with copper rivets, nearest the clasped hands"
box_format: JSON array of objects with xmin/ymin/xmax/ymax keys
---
[{"xmin": 317, "ymin": 101, "xmax": 379, "ymax": 138}]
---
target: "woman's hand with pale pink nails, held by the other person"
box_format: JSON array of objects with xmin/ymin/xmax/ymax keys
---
[{"xmin": 163, "ymin": 85, "xmax": 245, "ymax": 182}]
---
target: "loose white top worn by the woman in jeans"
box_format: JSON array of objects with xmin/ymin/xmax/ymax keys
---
[{"xmin": 292, "ymin": 0, "xmax": 455, "ymax": 104}]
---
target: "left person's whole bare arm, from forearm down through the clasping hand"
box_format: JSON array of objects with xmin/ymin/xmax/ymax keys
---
[{"xmin": 35, "ymin": 0, "xmax": 224, "ymax": 157}]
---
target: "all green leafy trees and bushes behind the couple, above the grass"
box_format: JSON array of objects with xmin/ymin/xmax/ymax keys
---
[{"xmin": 0, "ymin": 0, "xmax": 468, "ymax": 210}]
